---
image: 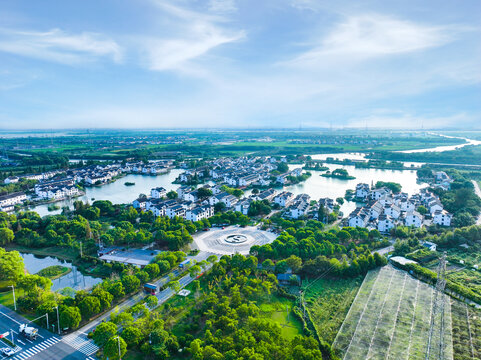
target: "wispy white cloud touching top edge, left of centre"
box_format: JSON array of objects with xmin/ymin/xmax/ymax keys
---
[{"xmin": 141, "ymin": 1, "xmax": 245, "ymax": 73}]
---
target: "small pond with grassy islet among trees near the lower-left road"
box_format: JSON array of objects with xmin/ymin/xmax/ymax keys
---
[{"xmin": 20, "ymin": 253, "xmax": 102, "ymax": 291}]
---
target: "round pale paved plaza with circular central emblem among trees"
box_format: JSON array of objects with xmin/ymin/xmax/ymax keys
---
[{"xmin": 190, "ymin": 226, "xmax": 276, "ymax": 255}]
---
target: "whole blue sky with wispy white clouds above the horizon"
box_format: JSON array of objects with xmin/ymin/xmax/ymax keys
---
[{"xmin": 0, "ymin": 0, "xmax": 481, "ymax": 129}]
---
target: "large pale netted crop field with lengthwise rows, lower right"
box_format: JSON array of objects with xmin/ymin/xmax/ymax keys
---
[{"xmin": 333, "ymin": 266, "xmax": 453, "ymax": 360}]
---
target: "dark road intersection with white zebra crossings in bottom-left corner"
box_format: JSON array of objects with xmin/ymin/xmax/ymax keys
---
[{"xmin": 0, "ymin": 305, "xmax": 87, "ymax": 360}]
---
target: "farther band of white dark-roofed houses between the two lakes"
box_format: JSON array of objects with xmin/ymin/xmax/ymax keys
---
[{"xmin": 177, "ymin": 156, "xmax": 302, "ymax": 188}]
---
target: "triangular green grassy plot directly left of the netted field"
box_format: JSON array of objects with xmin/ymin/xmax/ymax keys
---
[{"xmin": 303, "ymin": 277, "xmax": 363, "ymax": 344}]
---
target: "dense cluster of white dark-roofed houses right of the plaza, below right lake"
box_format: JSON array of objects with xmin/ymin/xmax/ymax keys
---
[{"xmin": 347, "ymin": 184, "xmax": 453, "ymax": 233}]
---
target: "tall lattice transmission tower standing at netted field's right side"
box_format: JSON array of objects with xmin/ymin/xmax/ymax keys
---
[{"xmin": 426, "ymin": 253, "xmax": 446, "ymax": 360}]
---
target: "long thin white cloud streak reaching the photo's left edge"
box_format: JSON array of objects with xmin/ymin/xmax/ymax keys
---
[{"xmin": 0, "ymin": 29, "xmax": 122, "ymax": 64}]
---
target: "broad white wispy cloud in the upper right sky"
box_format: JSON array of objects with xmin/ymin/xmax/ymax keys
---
[{"xmin": 287, "ymin": 14, "xmax": 452, "ymax": 66}]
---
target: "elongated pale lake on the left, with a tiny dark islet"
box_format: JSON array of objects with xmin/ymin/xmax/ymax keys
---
[{"xmin": 32, "ymin": 169, "xmax": 184, "ymax": 216}]
